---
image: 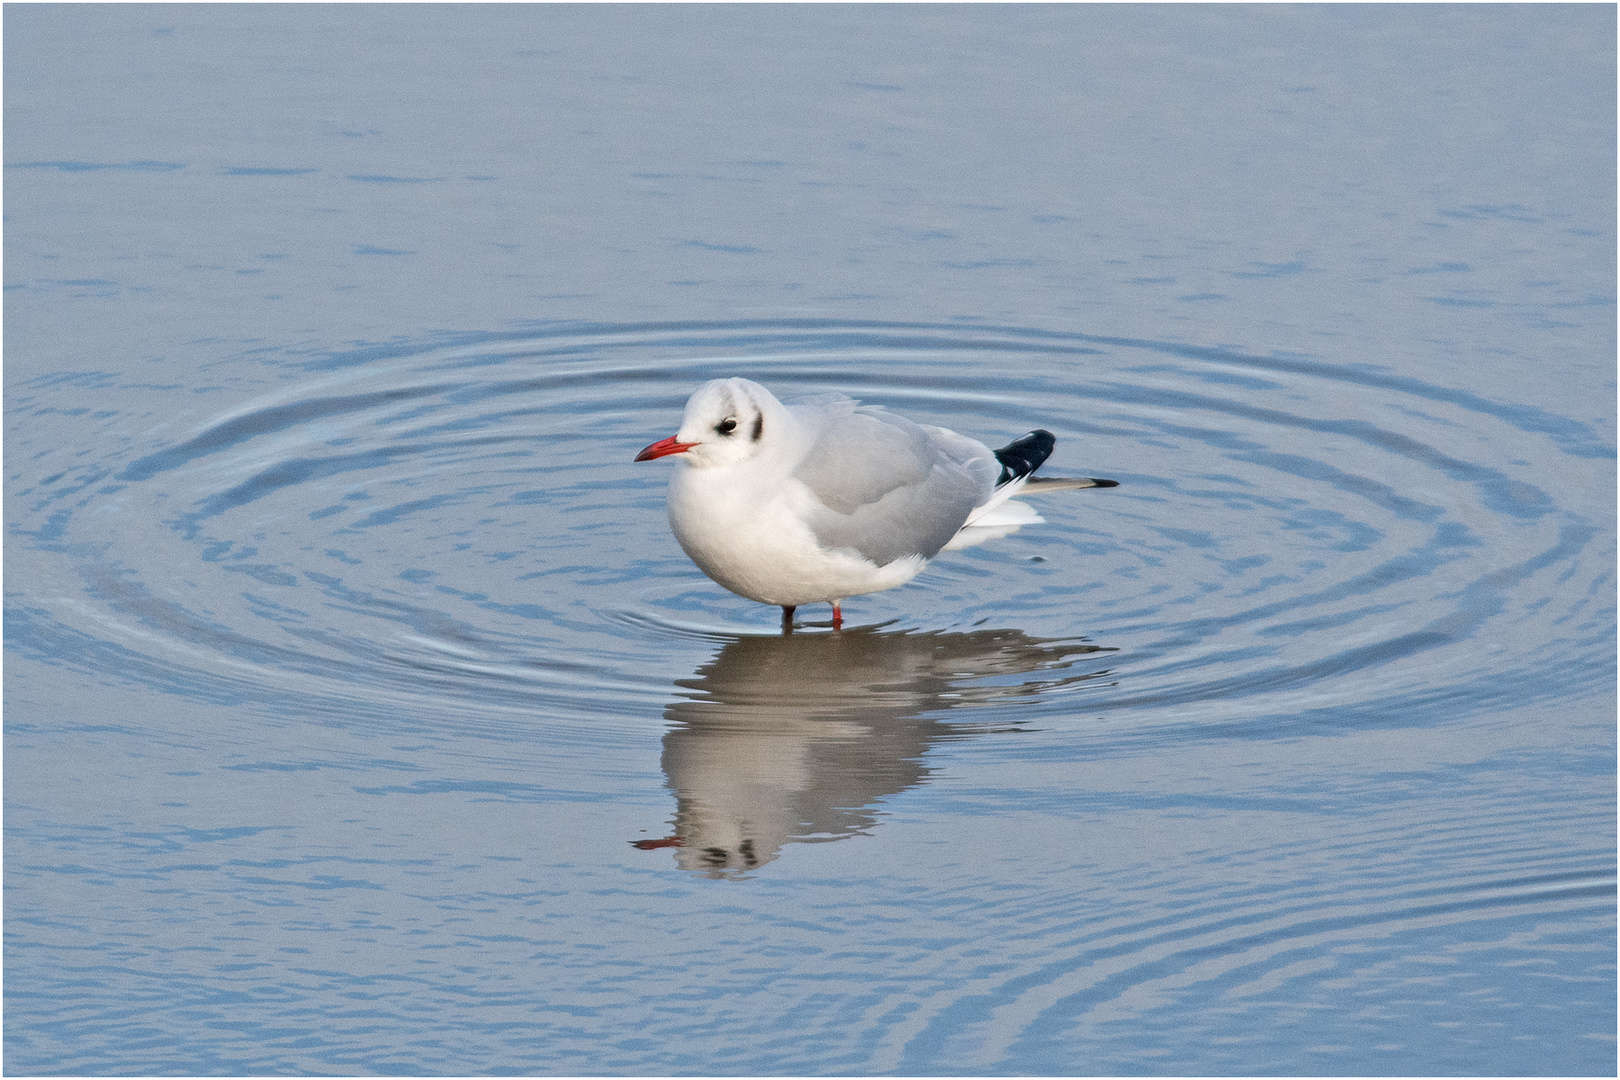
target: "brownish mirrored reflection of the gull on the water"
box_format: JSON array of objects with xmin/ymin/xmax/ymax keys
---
[{"xmin": 635, "ymin": 630, "xmax": 1113, "ymax": 878}]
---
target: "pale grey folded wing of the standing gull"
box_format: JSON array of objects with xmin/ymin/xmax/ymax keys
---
[{"xmin": 794, "ymin": 398, "xmax": 1000, "ymax": 567}]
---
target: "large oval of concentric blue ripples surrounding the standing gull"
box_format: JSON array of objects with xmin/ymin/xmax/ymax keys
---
[{"xmin": 10, "ymin": 322, "xmax": 1614, "ymax": 737}]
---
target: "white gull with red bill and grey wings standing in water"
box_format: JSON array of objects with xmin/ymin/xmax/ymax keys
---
[{"xmin": 635, "ymin": 379, "xmax": 1118, "ymax": 633}]
